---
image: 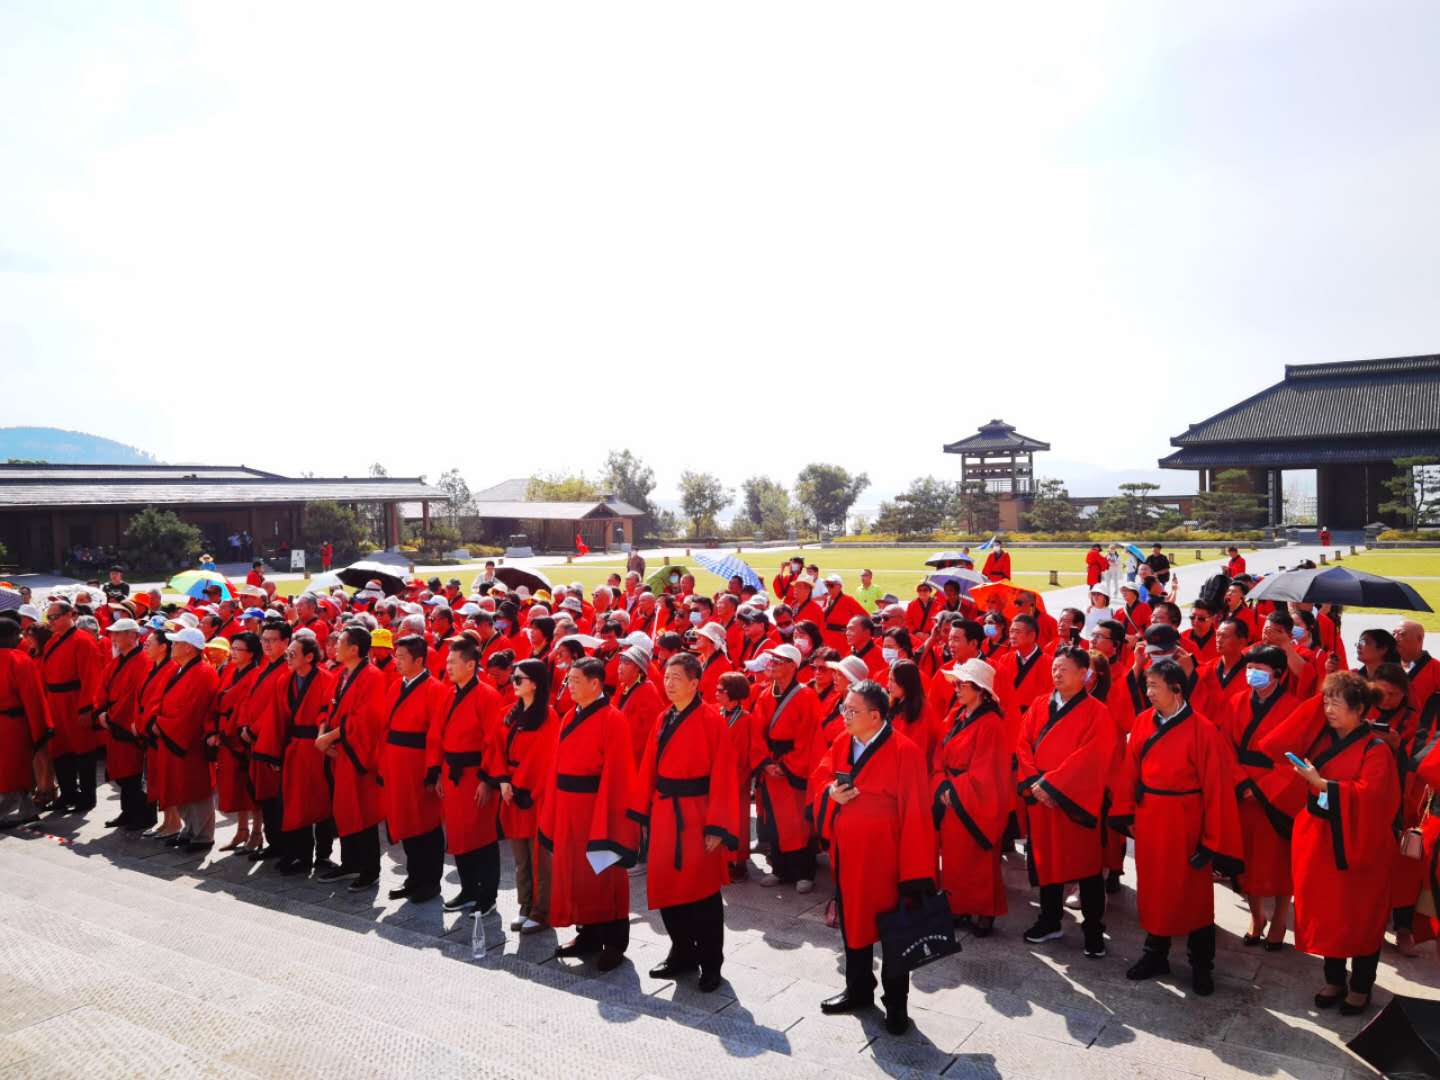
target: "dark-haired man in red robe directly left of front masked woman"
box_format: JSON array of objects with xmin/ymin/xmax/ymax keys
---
[{"xmin": 1112, "ymin": 660, "xmax": 1243, "ymax": 996}]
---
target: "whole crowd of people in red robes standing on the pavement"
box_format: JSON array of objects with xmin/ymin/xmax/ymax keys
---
[{"xmin": 0, "ymin": 546, "xmax": 1440, "ymax": 1032}]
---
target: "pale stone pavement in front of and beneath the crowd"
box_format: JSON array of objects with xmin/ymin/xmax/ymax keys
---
[{"xmin": 0, "ymin": 798, "xmax": 1440, "ymax": 1080}]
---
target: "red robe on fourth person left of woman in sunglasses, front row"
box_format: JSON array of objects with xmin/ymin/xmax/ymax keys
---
[{"xmin": 251, "ymin": 665, "xmax": 336, "ymax": 832}]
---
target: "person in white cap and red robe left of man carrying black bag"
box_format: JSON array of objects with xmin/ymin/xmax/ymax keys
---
[{"xmin": 750, "ymin": 645, "xmax": 821, "ymax": 893}]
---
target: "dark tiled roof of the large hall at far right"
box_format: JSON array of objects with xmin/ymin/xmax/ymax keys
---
[{"xmin": 1171, "ymin": 356, "xmax": 1440, "ymax": 452}]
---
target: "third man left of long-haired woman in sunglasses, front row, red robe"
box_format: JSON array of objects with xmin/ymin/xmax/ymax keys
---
[{"xmin": 315, "ymin": 624, "xmax": 386, "ymax": 893}]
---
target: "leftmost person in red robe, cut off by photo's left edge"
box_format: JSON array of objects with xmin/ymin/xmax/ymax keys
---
[{"xmin": 0, "ymin": 616, "xmax": 53, "ymax": 831}]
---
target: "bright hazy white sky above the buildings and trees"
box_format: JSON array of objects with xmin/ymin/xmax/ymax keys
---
[{"xmin": 0, "ymin": 0, "xmax": 1440, "ymax": 497}]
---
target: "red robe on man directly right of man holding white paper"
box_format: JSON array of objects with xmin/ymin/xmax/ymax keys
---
[{"xmin": 635, "ymin": 697, "xmax": 740, "ymax": 907}]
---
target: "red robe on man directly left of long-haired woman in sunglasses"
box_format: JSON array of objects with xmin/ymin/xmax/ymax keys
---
[{"xmin": 431, "ymin": 675, "xmax": 504, "ymax": 855}]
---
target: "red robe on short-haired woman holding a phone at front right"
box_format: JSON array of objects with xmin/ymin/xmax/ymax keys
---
[{"xmin": 1292, "ymin": 724, "xmax": 1400, "ymax": 956}]
